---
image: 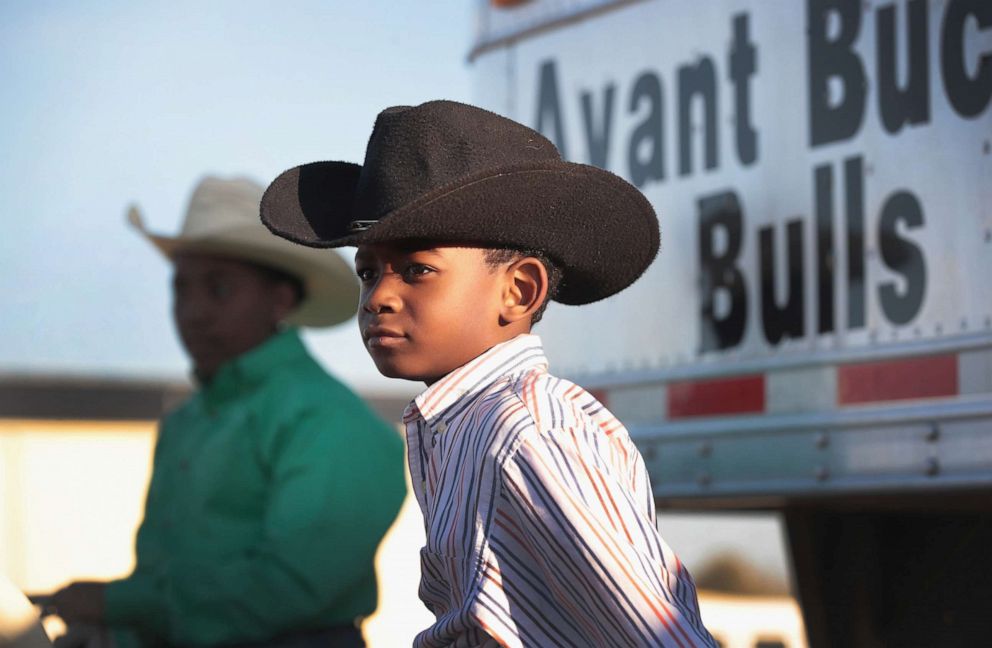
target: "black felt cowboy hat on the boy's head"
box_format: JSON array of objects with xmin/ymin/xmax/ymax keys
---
[{"xmin": 261, "ymin": 101, "xmax": 659, "ymax": 304}]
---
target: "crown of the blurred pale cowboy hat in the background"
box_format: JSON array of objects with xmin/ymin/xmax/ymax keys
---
[{"xmin": 181, "ymin": 176, "xmax": 268, "ymax": 239}]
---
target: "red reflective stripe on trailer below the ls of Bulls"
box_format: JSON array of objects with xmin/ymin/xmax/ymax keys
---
[{"xmin": 837, "ymin": 354, "xmax": 958, "ymax": 405}]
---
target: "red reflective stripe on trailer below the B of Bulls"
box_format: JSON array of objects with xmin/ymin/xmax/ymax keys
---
[{"xmin": 667, "ymin": 374, "xmax": 765, "ymax": 419}]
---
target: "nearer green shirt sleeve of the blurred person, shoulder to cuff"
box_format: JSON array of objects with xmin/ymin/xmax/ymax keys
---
[{"xmin": 106, "ymin": 408, "xmax": 405, "ymax": 645}]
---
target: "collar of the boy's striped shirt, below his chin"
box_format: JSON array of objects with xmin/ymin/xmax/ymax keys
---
[{"xmin": 403, "ymin": 333, "xmax": 548, "ymax": 423}]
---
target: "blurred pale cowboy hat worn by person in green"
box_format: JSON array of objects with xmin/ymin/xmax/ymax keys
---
[{"xmin": 127, "ymin": 177, "xmax": 358, "ymax": 327}]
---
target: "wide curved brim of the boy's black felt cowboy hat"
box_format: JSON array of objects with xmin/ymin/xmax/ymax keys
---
[{"xmin": 261, "ymin": 160, "xmax": 660, "ymax": 305}]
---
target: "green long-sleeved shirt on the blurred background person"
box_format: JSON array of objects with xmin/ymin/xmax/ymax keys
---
[{"xmin": 105, "ymin": 329, "xmax": 406, "ymax": 646}]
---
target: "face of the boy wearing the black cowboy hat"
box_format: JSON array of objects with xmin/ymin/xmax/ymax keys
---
[{"xmin": 355, "ymin": 244, "xmax": 516, "ymax": 384}]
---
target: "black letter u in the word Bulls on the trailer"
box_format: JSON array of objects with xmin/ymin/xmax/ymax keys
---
[{"xmin": 758, "ymin": 220, "xmax": 805, "ymax": 344}]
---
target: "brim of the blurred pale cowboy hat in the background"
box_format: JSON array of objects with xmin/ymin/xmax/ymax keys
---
[{"xmin": 142, "ymin": 228, "xmax": 358, "ymax": 328}]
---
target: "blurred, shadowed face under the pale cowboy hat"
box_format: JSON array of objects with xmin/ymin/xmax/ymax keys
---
[{"xmin": 172, "ymin": 254, "xmax": 294, "ymax": 381}]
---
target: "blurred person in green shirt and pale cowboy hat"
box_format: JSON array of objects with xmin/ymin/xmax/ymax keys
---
[{"xmin": 53, "ymin": 178, "xmax": 405, "ymax": 647}]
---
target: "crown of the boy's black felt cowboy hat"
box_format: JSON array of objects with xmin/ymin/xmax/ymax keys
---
[{"xmin": 352, "ymin": 101, "xmax": 561, "ymax": 221}]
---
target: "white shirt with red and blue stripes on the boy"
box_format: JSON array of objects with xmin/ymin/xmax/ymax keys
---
[{"xmin": 403, "ymin": 335, "xmax": 716, "ymax": 648}]
